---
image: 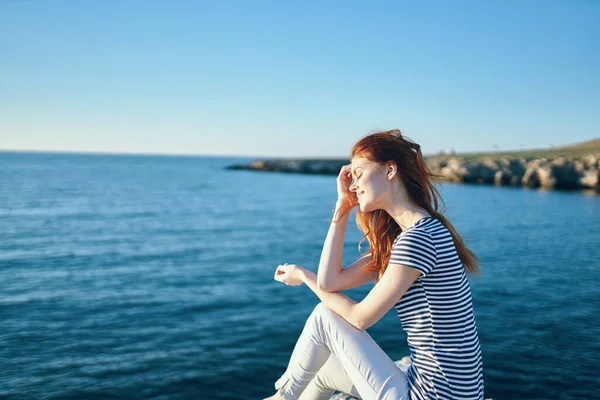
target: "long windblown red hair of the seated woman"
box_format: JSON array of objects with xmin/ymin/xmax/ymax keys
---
[{"xmin": 338, "ymin": 129, "xmax": 479, "ymax": 278}]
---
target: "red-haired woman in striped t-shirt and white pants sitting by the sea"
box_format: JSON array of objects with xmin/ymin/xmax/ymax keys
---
[{"xmin": 269, "ymin": 130, "xmax": 483, "ymax": 400}]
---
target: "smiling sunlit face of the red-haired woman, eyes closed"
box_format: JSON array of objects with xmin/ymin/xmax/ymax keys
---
[{"xmin": 349, "ymin": 157, "xmax": 391, "ymax": 212}]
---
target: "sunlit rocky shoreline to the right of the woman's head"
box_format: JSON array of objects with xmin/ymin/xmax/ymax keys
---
[{"xmin": 427, "ymin": 154, "xmax": 600, "ymax": 191}]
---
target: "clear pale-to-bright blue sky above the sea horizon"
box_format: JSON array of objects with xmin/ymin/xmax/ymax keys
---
[{"xmin": 0, "ymin": 0, "xmax": 600, "ymax": 157}]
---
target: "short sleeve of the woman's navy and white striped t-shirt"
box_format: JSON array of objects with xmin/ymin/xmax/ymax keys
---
[{"xmin": 390, "ymin": 229, "xmax": 437, "ymax": 276}]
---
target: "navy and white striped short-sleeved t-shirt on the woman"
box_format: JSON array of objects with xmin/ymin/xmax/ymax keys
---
[{"xmin": 390, "ymin": 217, "xmax": 483, "ymax": 400}]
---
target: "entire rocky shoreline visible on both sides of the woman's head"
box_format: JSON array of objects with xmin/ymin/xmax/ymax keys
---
[{"xmin": 227, "ymin": 152, "xmax": 600, "ymax": 192}]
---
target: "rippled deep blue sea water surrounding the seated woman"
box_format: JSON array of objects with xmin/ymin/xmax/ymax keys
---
[{"xmin": 0, "ymin": 153, "xmax": 600, "ymax": 400}]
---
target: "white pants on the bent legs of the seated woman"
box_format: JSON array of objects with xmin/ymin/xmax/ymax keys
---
[{"xmin": 275, "ymin": 303, "xmax": 408, "ymax": 400}]
